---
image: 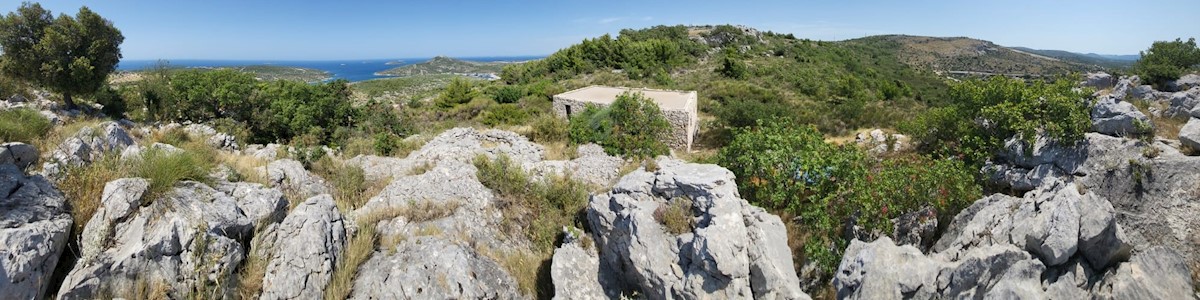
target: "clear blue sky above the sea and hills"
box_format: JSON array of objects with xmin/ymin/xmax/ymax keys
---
[{"xmin": 16, "ymin": 0, "xmax": 1200, "ymax": 60}]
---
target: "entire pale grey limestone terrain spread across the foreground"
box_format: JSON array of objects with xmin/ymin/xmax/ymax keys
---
[{"xmin": 0, "ymin": 73, "xmax": 1200, "ymax": 299}]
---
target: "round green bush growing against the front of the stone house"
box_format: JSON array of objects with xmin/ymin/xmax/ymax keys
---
[{"xmin": 570, "ymin": 92, "xmax": 671, "ymax": 157}]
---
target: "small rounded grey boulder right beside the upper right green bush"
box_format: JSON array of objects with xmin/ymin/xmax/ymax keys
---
[{"xmin": 1092, "ymin": 96, "xmax": 1153, "ymax": 137}]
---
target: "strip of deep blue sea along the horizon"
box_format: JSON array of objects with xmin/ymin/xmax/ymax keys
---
[{"xmin": 116, "ymin": 56, "xmax": 544, "ymax": 82}]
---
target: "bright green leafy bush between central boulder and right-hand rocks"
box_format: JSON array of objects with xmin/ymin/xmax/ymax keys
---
[{"xmin": 718, "ymin": 120, "xmax": 980, "ymax": 271}]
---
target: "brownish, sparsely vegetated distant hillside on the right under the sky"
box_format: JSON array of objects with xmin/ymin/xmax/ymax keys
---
[{"xmin": 846, "ymin": 35, "xmax": 1104, "ymax": 76}]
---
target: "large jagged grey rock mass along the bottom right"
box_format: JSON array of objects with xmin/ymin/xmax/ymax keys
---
[{"xmin": 834, "ymin": 181, "xmax": 1192, "ymax": 299}]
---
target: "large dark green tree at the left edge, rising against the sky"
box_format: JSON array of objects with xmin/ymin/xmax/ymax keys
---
[{"xmin": 0, "ymin": 2, "xmax": 125, "ymax": 109}]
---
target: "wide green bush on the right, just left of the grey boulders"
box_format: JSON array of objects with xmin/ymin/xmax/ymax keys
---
[{"xmin": 901, "ymin": 77, "xmax": 1091, "ymax": 166}]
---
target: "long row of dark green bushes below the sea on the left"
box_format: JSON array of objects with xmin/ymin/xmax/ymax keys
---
[{"xmin": 123, "ymin": 70, "xmax": 364, "ymax": 144}]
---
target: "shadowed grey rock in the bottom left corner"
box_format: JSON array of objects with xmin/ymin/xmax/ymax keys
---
[{"xmin": 0, "ymin": 163, "xmax": 72, "ymax": 299}]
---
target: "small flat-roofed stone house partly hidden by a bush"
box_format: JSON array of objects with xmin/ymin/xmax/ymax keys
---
[{"xmin": 553, "ymin": 85, "xmax": 697, "ymax": 151}]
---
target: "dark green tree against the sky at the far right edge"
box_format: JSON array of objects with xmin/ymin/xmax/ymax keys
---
[{"xmin": 1134, "ymin": 37, "xmax": 1200, "ymax": 85}]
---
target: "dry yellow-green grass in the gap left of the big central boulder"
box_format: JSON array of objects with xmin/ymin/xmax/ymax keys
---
[{"xmin": 474, "ymin": 155, "xmax": 590, "ymax": 298}]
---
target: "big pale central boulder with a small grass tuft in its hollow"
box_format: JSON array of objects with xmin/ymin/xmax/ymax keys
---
[{"xmin": 588, "ymin": 158, "xmax": 809, "ymax": 299}]
